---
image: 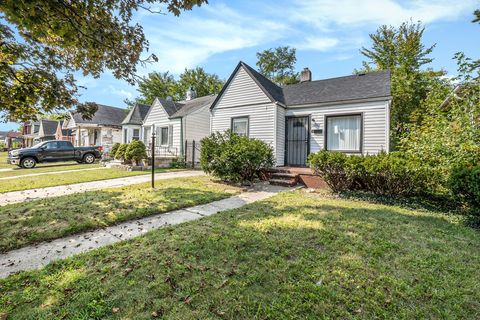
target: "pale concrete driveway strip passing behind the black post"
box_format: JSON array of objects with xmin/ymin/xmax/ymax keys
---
[{"xmin": 0, "ymin": 170, "xmax": 205, "ymax": 206}]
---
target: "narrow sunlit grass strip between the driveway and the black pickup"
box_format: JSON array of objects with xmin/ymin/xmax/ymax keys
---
[{"xmin": 0, "ymin": 169, "xmax": 176, "ymax": 192}]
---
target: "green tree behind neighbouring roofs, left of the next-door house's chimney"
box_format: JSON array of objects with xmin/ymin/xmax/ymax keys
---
[{"xmin": 125, "ymin": 71, "xmax": 177, "ymax": 105}]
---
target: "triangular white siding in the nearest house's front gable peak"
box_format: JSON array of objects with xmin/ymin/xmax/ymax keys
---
[{"xmin": 215, "ymin": 67, "xmax": 270, "ymax": 109}]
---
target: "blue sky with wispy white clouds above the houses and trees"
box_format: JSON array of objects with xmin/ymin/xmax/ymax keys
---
[{"xmin": 0, "ymin": 0, "xmax": 480, "ymax": 131}]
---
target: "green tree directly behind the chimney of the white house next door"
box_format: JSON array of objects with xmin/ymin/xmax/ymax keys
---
[{"xmin": 175, "ymin": 67, "xmax": 224, "ymax": 100}]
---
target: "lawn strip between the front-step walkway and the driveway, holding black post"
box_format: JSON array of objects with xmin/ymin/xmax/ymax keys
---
[{"xmin": 0, "ymin": 176, "xmax": 239, "ymax": 252}]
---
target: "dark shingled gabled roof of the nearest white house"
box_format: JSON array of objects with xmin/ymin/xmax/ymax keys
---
[{"xmin": 211, "ymin": 61, "xmax": 390, "ymax": 108}]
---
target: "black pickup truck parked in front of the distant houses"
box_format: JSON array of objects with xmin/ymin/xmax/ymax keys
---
[{"xmin": 7, "ymin": 140, "xmax": 102, "ymax": 169}]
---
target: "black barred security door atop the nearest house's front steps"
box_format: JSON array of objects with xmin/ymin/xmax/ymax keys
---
[{"xmin": 285, "ymin": 117, "xmax": 310, "ymax": 166}]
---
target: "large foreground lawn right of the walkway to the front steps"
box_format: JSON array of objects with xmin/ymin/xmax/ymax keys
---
[{"xmin": 0, "ymin": 191, "xmax": 480, "ymax": 319}]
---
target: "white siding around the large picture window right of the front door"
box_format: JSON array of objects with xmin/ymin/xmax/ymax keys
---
[{"xmin": 286, "ymin": 101, "xmax": 388, "ymax": 154}]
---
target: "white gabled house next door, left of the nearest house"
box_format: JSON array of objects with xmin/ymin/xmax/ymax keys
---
[{"xmin": 141, "ymin": 88, "xmax": 216, "ymax": 157}]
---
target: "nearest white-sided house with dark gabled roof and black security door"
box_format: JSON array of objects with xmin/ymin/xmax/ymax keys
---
[{"xmin": 211, "ymin": 62, "xmax": 391, "ymax": 166}]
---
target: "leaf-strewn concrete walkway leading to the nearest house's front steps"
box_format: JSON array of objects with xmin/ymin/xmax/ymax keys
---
[{"xmin": 0, "ymin": 183, "xmax": 292, "ymax": 278}]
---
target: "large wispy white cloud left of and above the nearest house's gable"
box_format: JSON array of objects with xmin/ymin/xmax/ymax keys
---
[{"xmin": 140, "ymin": 5, "xmax": 287, "ymax": 73}]
